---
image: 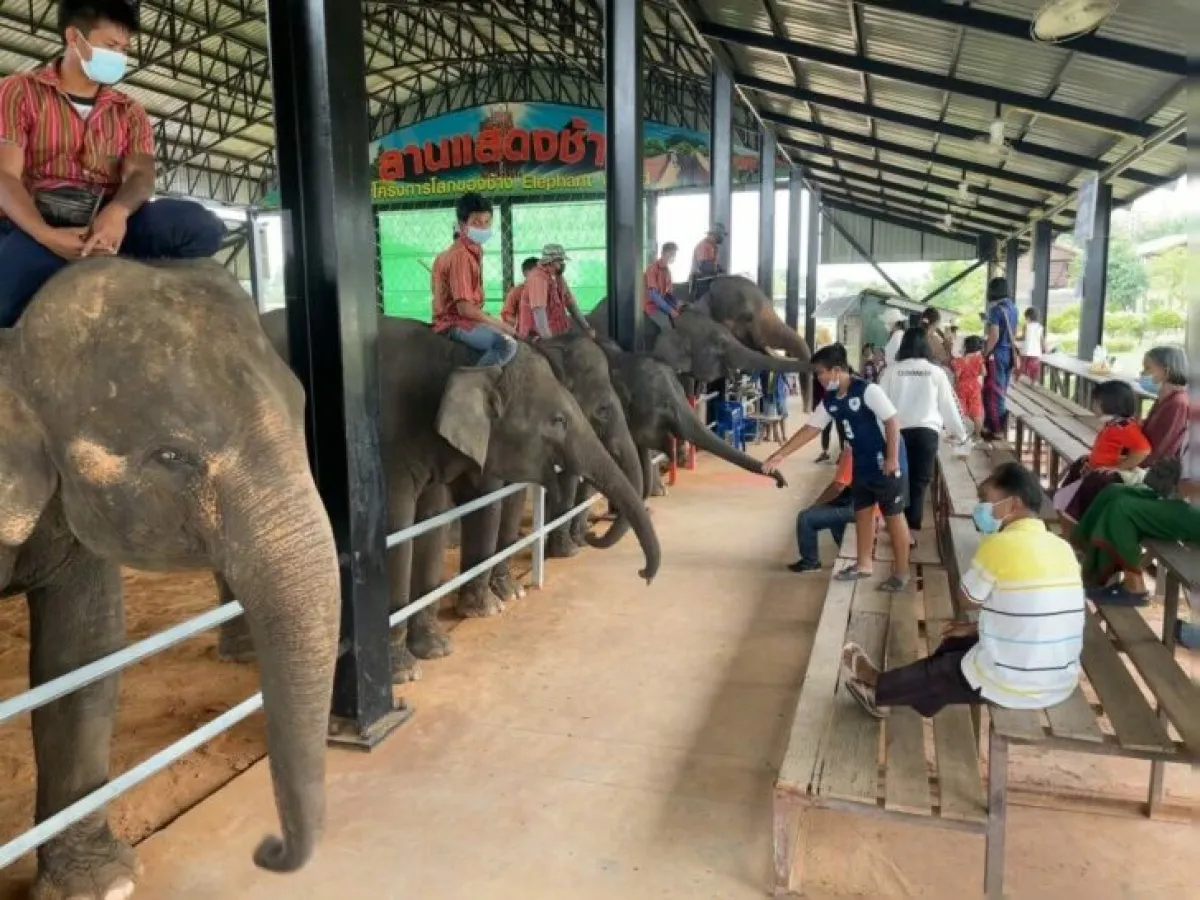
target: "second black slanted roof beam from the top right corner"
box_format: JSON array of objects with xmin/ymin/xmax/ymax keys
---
[{"xmin": 698, "ymin": 22, "xmax": 1176, "ymax": 138}]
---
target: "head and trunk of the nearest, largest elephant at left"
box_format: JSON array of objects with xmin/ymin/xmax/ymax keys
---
[{"xmin": 0, "ymin": 258, "xmax": 340, "ymax": 871}]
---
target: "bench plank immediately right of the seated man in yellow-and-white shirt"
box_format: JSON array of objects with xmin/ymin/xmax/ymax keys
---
[{"xmin": 1082, "ymin": 612, "xmax": 1175, "ymax": 751}]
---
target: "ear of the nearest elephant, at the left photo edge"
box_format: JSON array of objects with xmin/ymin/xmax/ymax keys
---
[{"xmin": 0, "ymin": 331, "xmax": 58, "ymax": 549}]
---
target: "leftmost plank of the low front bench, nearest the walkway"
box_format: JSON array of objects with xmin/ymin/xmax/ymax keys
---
[{"xmin": 776, "ymin": 571, "xmax": 854, "ymax": 793}]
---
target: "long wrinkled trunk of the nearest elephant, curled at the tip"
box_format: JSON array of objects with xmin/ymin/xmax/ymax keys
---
[{"xmin": 218, "ymin": 442, "xmax": 341, "ymax": 872}]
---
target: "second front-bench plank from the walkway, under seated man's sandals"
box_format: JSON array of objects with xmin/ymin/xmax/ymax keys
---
[{"xmin": 817, "ymin": 609, "xmax": 888, "ymax": 806}]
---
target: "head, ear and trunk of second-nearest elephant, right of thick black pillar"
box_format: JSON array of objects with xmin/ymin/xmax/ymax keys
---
[{"xmin": 437, "ymin": 344, "xmax": 661, "ymax": 582}]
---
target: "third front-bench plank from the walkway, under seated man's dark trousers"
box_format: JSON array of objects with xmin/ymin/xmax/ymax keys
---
[{"xmin": 883, "ymin": 596, "xmax": 932, "ymax": 816}]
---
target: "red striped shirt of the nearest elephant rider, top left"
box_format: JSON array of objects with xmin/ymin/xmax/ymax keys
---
[{"xmin": 0, "ymin": 60, "xmax": 154, "ymax": 207}]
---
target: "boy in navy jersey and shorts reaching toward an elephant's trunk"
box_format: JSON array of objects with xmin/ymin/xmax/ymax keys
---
[{"xmin": 763, "ymin": 343, "xmax": 908, "ymax": 593}]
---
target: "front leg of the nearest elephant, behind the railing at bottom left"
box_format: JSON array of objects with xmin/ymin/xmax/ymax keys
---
[{"xmin": 28, "ymin": 548, "xmax": 140, "ymax": 900}]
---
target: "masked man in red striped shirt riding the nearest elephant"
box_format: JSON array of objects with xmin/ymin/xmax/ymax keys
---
[{"xmin": 0, "ymin": 0, "xmax": 224, "ymax": 328}]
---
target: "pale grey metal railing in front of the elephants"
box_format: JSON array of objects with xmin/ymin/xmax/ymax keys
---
[{"xmin": 0, "ymin": 484, "xmax": 602, "ymax": 869}]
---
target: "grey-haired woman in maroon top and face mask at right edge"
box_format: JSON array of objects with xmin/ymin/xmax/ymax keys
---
[{"xmin": 1064, "ymin": 347, "xmax": 1188, "ymax": 522}]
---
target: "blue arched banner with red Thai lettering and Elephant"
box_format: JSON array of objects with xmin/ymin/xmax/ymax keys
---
[{"xmin": 371, "ymin": 103, "xmax": 758, "ymax": 203}]
